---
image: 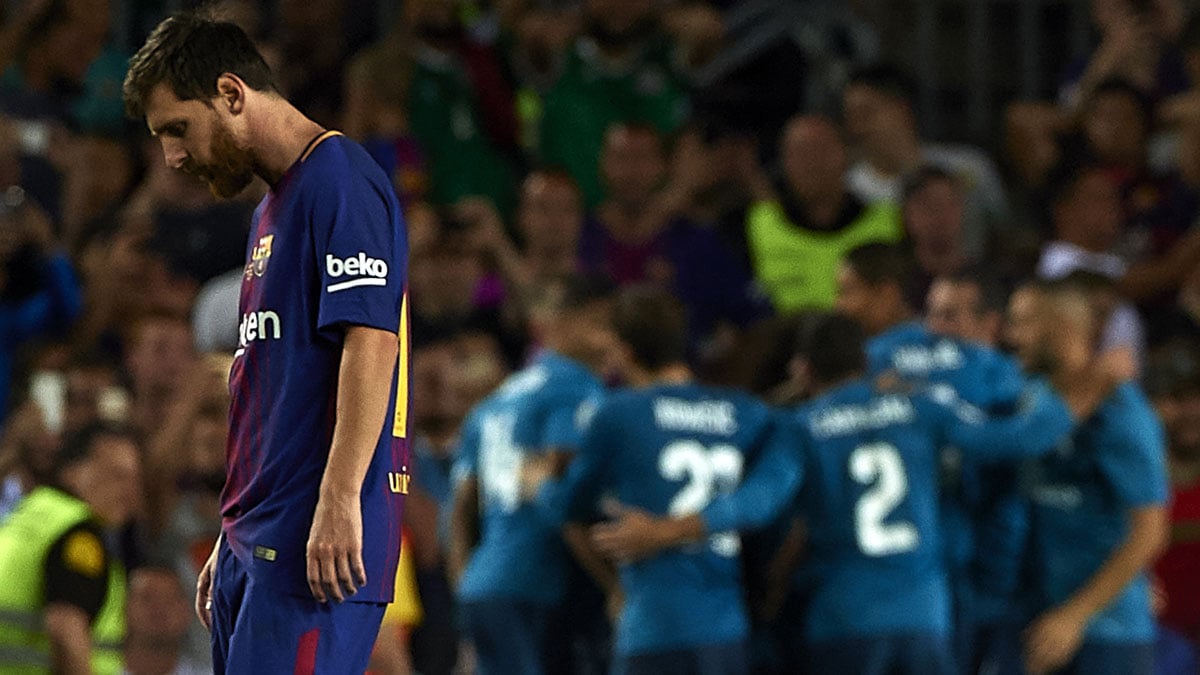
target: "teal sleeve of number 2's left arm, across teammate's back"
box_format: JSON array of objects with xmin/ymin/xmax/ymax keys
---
[{"xmin": 700, "ymin": 414, "xmax": 803, "ymax": 532}]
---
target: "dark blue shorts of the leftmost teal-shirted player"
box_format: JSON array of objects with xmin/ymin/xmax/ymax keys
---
[{"xmin": 460, "ymin": 599, "xmax": 556, "ymax": 675}]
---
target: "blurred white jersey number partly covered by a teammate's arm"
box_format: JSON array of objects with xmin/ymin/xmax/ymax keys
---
[{"xmin": 659, "ymin": 441, "xmax": 743, "ymax": 557}]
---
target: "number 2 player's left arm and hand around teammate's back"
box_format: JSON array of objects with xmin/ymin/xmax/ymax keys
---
[{"xmin": 593, "ymin": 417, "xmax": 802, "ymax": 561}]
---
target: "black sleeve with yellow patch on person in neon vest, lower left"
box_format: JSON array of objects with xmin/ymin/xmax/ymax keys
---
[{"xmin": 46, "ymin": 524, "xmax": 108, "ymax": 621}]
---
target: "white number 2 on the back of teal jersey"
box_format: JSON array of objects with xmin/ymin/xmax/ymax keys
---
[{"xmin": 850, "ymin": 443, "xmax": 920, "ymax": 556}]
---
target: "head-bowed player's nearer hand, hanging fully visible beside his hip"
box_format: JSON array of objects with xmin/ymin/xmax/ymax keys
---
[{"xmin": 306, "ymin": 494, "xmax": 367, "ymax": 602}]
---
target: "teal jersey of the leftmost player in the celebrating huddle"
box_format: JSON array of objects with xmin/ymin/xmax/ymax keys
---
[{"xmin": 455, "ymin": 353, "xmax": 602, "ymax": 604}]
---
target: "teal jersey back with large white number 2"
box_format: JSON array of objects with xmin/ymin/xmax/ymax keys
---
[{"xmin": 794, "ymin": 381, "xmax": 949, "ymax": 643}]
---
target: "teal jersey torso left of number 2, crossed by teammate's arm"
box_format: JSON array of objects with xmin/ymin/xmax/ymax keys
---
[{"xmin": 583, "ymin": 384, "xmax": 778, "ymax": 655}]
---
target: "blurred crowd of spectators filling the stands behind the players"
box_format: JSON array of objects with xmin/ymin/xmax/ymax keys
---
[{"xmin": 0, "ymin": 0, "xmax": 1200, "ymax": 675}]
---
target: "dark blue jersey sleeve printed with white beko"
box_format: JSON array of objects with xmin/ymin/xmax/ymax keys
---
[{"xmin": 312, "ymin": 154, "xmax": 407, "ymax": 339}]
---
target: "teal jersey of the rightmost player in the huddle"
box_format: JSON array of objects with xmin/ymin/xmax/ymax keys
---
[{"xmin": 1028, "ymin": 383, "xmax": 1168, "ymax": 641}]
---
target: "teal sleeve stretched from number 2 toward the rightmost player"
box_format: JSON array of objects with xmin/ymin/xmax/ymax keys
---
[{"xmin": 928, "ymin": 382, "xmax": 1075, "ymax": 461}]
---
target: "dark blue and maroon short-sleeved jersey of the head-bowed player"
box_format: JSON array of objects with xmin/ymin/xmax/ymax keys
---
[{"xmin": 221, "ymin": 132, "xmax": 410, "ymax": 602}]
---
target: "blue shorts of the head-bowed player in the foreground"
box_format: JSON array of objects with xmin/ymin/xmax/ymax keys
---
[{"xmin": 212, "ymin": 539, "xmax": 386, "ymax": 675}]
